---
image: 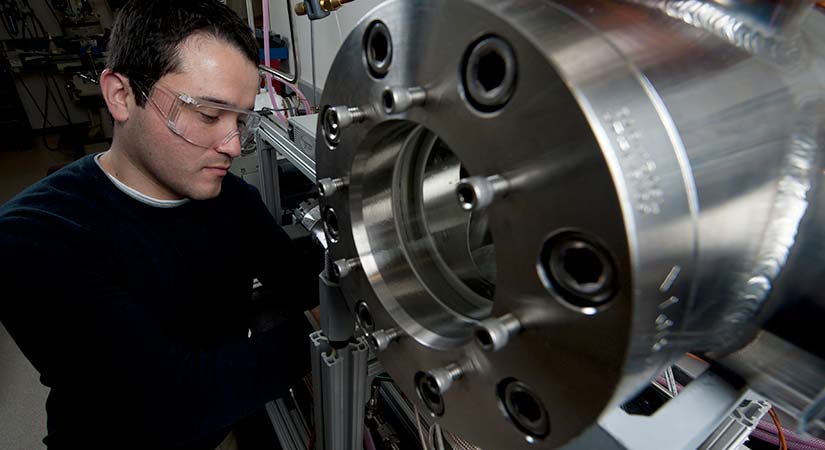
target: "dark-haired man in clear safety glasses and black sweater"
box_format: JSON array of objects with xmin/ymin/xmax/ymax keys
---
[{"xmin": 0, "ymin": 0, "xmax": 317, "ymax": 450}]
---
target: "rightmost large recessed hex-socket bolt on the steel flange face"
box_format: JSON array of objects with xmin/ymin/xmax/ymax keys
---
[{"xmin": 538, "ymin": 233, "xmax": 616, "ymax": 313}]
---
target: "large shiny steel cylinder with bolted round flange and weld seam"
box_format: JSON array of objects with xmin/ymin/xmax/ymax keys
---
[{"xmin": 316, "ymin": 0, "xmax": 825, "ymax": 449}]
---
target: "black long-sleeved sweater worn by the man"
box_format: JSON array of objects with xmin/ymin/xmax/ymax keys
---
[{"xmin": 0, "ymin": 157, "xmax": 317, "ymax": 450}]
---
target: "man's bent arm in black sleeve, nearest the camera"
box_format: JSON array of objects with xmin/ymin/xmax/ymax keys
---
[{"xmin": 0, "ymin": 227, "xmax": 309, "ymax": 445}]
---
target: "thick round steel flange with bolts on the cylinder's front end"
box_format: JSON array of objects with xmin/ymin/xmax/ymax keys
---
[{"xmin": 316, "ymin": 0, "xmax": 692, "ymax": 449}]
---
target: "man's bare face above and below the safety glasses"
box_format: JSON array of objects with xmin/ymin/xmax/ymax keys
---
[{"xmin": 127, "ymin": 35, "xmax": 259, "ymax": 200}]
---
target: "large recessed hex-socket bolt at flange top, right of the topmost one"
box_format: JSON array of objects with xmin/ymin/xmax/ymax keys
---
[{"xmin": 462, "ymin": 36, "xmax": 516, "ymax": 112}]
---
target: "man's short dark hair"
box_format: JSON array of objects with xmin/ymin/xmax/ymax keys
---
[{"xmin": 106, "ymin": 0, "xmax": 259, "ymax": 106}]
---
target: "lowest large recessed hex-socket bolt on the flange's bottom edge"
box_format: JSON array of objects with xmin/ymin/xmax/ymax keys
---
[{"xmin": 498, "ymin": 378, "xmax": 550, "ymax": 443}]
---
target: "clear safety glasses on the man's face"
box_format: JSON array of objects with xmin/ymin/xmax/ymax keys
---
[{"xmin": 136, "ymin": 82, "xmax": 261, "ymax": 148}]
